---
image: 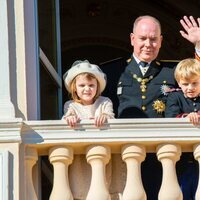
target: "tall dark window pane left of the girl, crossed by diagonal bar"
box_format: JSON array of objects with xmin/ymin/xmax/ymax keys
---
[{"xmin": 37, "ymin": 0, "xmax": 62, "ymax": 120}]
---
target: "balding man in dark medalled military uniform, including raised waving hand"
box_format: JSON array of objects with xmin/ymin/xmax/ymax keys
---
[{"xmin": 117, "ymin": 16, "xmax": 200, "ymax": 118}]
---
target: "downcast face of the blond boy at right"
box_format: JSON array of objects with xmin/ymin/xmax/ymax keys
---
[{"xmin": 178, "ymin": 76, "xmax": 200, "ymax": 98}]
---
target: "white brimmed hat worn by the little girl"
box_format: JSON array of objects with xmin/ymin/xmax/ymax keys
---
[{"xmin": 63, "ymin": 60, "xmax": 107, "ymax": 92}]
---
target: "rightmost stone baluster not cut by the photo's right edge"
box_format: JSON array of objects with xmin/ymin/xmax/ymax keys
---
[{"xmin": 157, "ymin": 144, "xmax": 183, "ymax": 200}]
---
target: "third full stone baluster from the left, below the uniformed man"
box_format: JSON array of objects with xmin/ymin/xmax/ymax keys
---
[{"xmin": 122, "ymin": 144, "xmax": 147, "ymax": 200}]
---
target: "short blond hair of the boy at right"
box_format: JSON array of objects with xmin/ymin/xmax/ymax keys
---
[{"xmin": 174, "ymin": 58, "xmax": 200, "ymax": 82}]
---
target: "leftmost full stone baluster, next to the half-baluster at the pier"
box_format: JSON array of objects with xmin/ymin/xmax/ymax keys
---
[{"xmin": 49, "ymin": 146, "xmax": 73, "ymax": 200}]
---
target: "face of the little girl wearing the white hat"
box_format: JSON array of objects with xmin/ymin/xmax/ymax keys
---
[{"xmin": 76, "ymin": 74, "xmax": 98, "ymax": 105}]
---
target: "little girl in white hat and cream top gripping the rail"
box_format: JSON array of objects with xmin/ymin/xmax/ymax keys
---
[{"xmin": 62, "ymin": 60, "xmax": 114, "ymax": 127}]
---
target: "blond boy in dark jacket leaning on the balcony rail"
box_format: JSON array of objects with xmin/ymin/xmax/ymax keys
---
[{"xmin": 165, "ymin": 58, "xmax": 200, "ymax": 125}]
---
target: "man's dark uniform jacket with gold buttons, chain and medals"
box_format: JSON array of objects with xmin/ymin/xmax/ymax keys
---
[{"xmin": 117, "ymin": 58, "xmax": 177, "ymax": 118}]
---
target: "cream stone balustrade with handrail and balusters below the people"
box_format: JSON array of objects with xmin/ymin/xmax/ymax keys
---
[{"xmin": 0, "ymin": 119, "xmax": 200, "ymax": 200}]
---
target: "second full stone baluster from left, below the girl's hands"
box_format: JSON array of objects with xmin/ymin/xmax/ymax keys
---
[{"xmin": 86, "ymin": 145, "xmax": 111, "ymax": 200}]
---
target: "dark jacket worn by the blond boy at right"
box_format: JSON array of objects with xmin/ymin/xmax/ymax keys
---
[{"xmin": 165, "ymin": 91, "xmax": 200, "ymax": 117}]
